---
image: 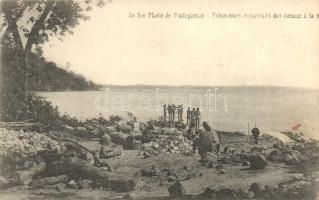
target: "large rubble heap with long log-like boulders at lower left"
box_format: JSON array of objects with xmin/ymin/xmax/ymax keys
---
[{"xmin": 0, "ymin": 129, "xmax": 136, "ymax": 192}]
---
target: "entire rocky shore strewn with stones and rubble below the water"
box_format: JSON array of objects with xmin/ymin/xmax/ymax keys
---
[{"xmin": 0, "ymin": 113, "xmax": 319, "ymax": 199}]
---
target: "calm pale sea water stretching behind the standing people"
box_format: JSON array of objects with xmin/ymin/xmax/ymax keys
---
[{"xmin": 38, "ymin": 87, "xmax": 319, "ymax": 138}]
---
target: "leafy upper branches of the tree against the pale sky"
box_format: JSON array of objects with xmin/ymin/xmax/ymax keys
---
[{"xmin": 1, "ymin": 0, "xmax": 105, "ymax": 53}]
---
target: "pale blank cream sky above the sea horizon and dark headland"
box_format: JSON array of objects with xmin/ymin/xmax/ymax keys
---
[{"xmin": 44, "ymin": 0, "xmax": 319, "ymax": 88}]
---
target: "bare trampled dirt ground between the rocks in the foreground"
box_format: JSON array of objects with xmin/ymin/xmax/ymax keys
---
[{"xmin": 0, "ymin": 133, "xmax": 310, "ymax": 199}]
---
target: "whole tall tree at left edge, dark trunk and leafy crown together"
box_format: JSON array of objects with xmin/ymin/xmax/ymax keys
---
[{"xmin": 0, "ymin": 0, "xmax": 105, "ymax": 121}]
